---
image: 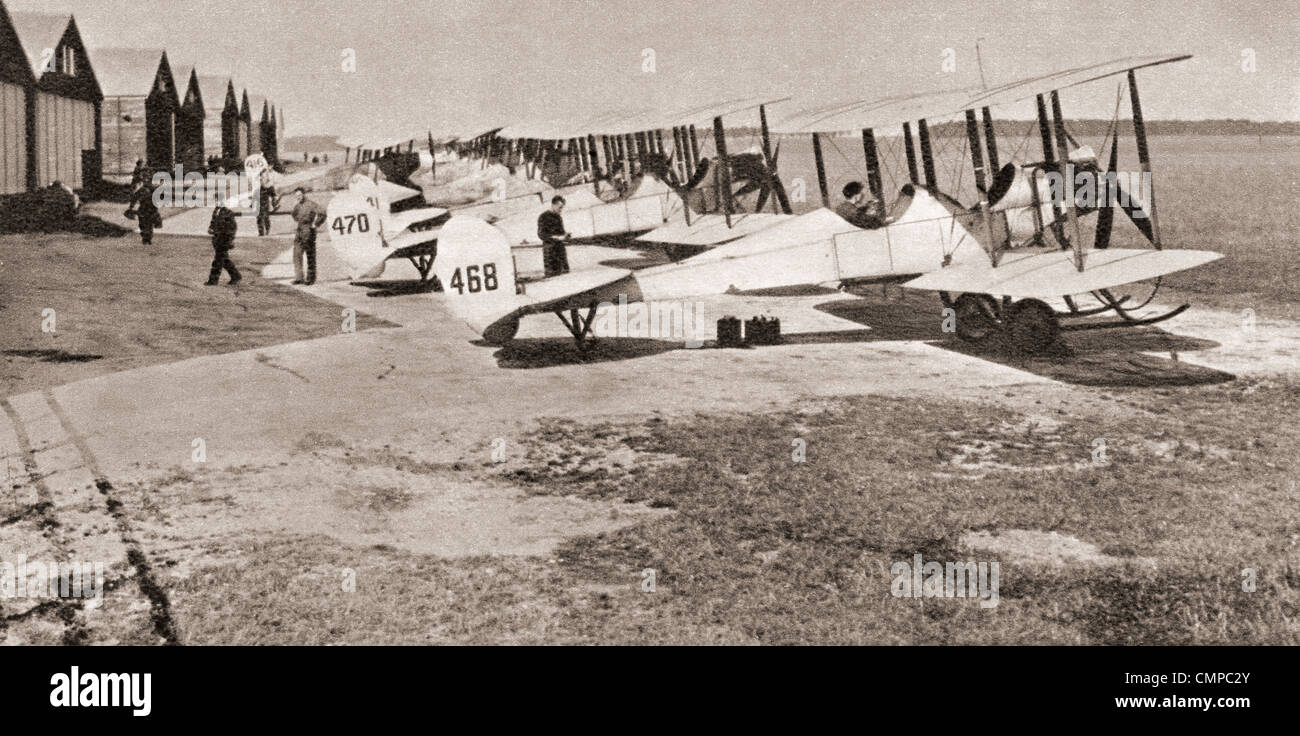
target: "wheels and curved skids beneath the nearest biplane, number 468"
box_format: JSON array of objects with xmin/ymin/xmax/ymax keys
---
[{"xmin": 939, "ymin": 283, "xmax": 1188, "ymax": 355}]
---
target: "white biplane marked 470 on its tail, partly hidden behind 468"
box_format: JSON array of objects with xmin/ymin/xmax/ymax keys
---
[{"xmin": 329, "ymin": 100, "xmax": 784, "ymax": 284}]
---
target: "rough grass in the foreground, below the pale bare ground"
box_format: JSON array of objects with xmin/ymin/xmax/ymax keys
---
[{"xmin": 162, "ymin": 381, "xmax": 1300, "ymax": 645}]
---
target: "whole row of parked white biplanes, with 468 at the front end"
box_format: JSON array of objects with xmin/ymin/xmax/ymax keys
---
[{"xmin": 317, "ymin": 56, "xmax": 1221, "ymax": 351}]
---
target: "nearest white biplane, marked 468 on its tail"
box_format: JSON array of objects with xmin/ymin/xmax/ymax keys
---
[{"xmin": 434, "ymin": 55, "xmax": 1221, "ymax": 351}]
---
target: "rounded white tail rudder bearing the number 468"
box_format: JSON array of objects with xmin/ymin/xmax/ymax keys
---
[{"xmin": 433, "ymin": 215, "xmax": 523, "ymax": 345}]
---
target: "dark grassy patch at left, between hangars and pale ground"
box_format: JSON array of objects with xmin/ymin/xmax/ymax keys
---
[{"xmin": 0, "ymin": 231, "xmax": 387, "ymax": 395}]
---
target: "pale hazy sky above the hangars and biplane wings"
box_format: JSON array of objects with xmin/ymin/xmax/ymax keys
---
[{"xmin": 0, "ymin": 0, "xmax": 1300, "ymax": 137}]
